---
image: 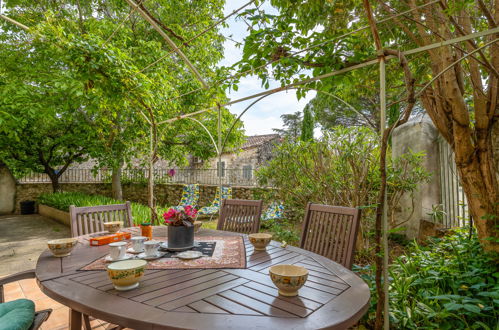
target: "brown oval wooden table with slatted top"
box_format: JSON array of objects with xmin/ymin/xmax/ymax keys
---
[{"xmin": 36, "ymin": 227, "xmax": 370, "ymax": 330}]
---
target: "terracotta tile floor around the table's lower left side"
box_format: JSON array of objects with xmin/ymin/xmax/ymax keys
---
[{"xmin": 4, "ymin": 279, "xmax": 119, "ymax": 330}]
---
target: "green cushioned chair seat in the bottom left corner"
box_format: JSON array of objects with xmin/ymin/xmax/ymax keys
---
[{"xmin": 0, "ymin": 299, "xmax": 35, "ymax": 330}]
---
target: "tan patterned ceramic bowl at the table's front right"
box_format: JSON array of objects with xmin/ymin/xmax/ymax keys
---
[{"xmin": 269, "ymin": 265, "xmax": 308, "ymax": 297}]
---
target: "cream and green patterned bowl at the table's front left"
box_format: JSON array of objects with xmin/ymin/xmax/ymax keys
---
[{"xmin": 107, "ymin": 259, "xmax": 147, "ymax": 291}]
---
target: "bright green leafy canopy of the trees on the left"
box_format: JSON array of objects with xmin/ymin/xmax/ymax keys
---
[{"xmin": 0, "ymin": 0, "xmax": 243, "ymax": 183}]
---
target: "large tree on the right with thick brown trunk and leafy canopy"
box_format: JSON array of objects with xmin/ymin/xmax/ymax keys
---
[{"xmin": 234, "ymin": 0, "xmax": 499, "ymax": 250}]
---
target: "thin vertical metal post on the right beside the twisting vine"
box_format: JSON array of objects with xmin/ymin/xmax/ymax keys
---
[{"xmin": 379, "ymin": 57, "xmax": 390, "ymax": 330}]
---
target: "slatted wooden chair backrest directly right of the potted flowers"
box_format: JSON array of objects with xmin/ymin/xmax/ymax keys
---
[{"xmin": 217, "ymin": 199, "xmax": 263, "ymax": 234}]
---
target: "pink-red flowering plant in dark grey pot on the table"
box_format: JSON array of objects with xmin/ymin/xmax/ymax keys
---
[{"xmin": 163, "ymin": 205, "xmax": 198, "ymax": 250}]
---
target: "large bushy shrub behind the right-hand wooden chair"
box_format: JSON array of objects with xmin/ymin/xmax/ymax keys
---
[{"xmin": 257, "ymin": 127, "xmax": 429, "ymax": 248}]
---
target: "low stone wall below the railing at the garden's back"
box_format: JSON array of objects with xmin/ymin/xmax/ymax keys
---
[{"xmin": 15, "ymin": 183, "xmax": 262, "ymax": 214}]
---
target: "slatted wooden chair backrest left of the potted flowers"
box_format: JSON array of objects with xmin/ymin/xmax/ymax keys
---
[{"xmin": 69, "ymin": 202, "xmax": 133, "ymax": 237}]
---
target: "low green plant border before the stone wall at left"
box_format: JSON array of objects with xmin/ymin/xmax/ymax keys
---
[{"xmin": 37, "ymin": 192, "xmax": 151, "ymax": 224}]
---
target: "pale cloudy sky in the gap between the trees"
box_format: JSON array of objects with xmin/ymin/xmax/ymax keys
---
[{"xmin": 220, "ymin": 0, "xmax": 315, "ymax": 135}]
